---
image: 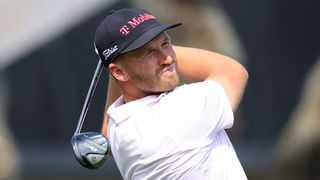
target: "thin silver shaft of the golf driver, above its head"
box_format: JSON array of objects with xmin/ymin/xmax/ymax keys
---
[{"xmin": 74, "ymin": 59, "xmax": 103, "ymax": 134}]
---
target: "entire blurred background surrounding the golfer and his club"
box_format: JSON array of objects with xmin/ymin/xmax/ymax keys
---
[{"xmin": 0, "ymin": 0, "xmax": 320, "ymax": 180}]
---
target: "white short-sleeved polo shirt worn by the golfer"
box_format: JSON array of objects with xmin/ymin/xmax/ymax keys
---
[{"xmin": 107, "ymin": 81, "xmax": 247, "ymax": 180}]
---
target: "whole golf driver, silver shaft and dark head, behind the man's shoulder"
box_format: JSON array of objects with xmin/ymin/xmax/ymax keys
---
[{"xmin": 71, "ymin": 60, "xmax": 109, "ymax": 169}]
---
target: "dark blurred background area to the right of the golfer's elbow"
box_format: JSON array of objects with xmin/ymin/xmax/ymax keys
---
[{"xmin": 221, "ymin": 0, "xmax": 320, "ymax": 164}]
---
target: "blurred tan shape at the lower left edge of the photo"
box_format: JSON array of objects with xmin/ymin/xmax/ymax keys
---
[{"xmin": 0, "ymin": 76, "xmax": 19, "ymax": 180}]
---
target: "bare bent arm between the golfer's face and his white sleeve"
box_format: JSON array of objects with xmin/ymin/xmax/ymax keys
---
[{"xmin": 174, "ymin": 46, "xmax": 248, "ymax": 111}]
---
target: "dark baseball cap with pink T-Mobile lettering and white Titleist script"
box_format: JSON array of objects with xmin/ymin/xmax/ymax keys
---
[{"xmin": 94, "ymin": 8, "xmax": 181, "ymax": 65}]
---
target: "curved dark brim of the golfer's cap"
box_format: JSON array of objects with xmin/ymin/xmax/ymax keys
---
[{"xmin": 121, "ymin": 23, "xmax": 182, "ymax": 53}]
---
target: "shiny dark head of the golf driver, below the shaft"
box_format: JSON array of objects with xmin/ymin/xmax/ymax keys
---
[{"xmin": 71, "ymin": 132, "xmax": 109, "ymax": 169}]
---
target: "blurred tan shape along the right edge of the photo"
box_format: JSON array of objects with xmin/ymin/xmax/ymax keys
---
[{"xmin": 270, "ymin": 58, "xmax": 320, "ymax": 180}]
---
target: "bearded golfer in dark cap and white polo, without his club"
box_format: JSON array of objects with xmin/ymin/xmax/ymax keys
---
[{"xmin": 95, "ymin": 9, "xmax": 248, "ymax": 180}]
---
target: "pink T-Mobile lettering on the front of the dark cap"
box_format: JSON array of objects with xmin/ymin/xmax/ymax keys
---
[{"xmin": 120, "ymin": 13, "xmax": 157, "ymax": 36}]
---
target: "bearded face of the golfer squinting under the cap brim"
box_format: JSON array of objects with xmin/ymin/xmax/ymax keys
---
[{"xmin": 122, "ymin": 33, "xmax": 180, "ymax": 94}]
